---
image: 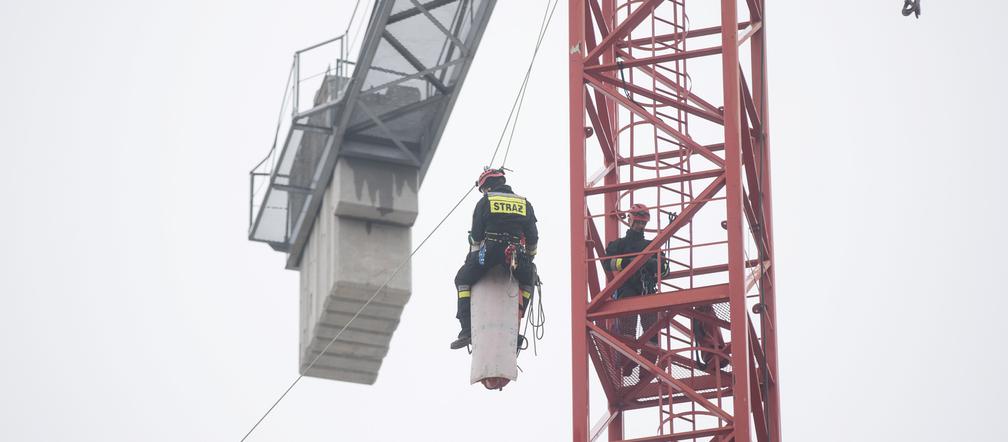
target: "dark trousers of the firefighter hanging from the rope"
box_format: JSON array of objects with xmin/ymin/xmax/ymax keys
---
[{"xmin": 455, "ymin": 240, "xmax": 536, "ymax": 330}]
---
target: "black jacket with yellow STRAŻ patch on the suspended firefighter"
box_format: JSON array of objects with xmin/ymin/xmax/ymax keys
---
[{"xmin": 469, "ymin": 186, "xmax": 539, "ymax": 249}]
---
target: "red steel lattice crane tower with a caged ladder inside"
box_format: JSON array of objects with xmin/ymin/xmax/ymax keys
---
[{"xmin": 569, "ymin": 0, "xmax": 780, "ymax": 442}]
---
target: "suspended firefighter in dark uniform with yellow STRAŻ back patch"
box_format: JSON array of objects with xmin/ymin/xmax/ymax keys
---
[{"xmin": 451, "ymin": 169, "xmax": 539, "ymax": 349}]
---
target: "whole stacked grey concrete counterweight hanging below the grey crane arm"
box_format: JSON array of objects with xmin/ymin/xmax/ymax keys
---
[{"xmin": 300, "ymin": 157, "xmax": 418, "ymax": 383}]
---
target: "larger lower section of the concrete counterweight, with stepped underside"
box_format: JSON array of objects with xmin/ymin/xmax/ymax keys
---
[{"xmin": 300, "ymin": 212, "xmax": 410, "ymax": 384}]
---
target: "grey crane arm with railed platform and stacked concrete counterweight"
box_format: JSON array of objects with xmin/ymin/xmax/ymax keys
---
[{"xmin": 268, "ymin": 0, "xmax": 495, "ymax": 383}]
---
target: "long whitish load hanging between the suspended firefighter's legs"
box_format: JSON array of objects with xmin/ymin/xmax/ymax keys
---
[{"xmin": 470, "ymin": 265, "xmax": 520, "ymax": 390}]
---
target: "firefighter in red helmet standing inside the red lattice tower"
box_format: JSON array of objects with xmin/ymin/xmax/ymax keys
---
[{"xmin": 602, "ymin": 204, "xmax": 668, "ymax": 376}]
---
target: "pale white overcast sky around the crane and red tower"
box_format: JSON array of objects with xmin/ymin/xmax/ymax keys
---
[{"xmin": 0, "ymin": 0, "xmax": 1008, "ymax": 442}]
